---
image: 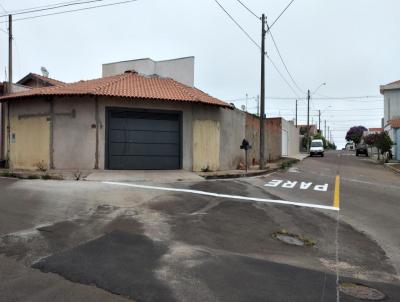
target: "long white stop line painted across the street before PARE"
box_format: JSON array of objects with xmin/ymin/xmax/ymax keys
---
[{"xmin": 102, "ymin": 181, "xmax": 339, "ymax": 211}]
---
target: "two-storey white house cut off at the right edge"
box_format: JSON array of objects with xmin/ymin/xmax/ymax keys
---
[{"xmin": 380, "ymin": 81, "xmax": 400, "ymax": 160}]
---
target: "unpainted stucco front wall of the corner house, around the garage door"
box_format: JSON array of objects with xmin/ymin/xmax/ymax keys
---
[{"xmin": 5, "ymin": 97, "xmax": 245, "ymax": 171}]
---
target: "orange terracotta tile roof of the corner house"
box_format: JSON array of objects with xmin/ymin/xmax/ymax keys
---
[{"xmin": 0, "ymin": 72, "xmax": 231, "ymax": 108}]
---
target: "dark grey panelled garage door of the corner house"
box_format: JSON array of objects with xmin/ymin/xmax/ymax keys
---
[{"xmin": 106, "ymin": 109, "xmax": 181, "ymax": 170}]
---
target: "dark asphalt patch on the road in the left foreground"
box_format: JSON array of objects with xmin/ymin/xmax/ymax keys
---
[{"xmin": 32, "ymin": 231, "xmax": 175, "ymax": 302}]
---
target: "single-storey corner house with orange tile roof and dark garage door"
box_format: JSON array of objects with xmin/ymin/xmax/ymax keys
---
[{"xmin": 0, "ymin": 70, "xmax": 256, "ymax": 171}]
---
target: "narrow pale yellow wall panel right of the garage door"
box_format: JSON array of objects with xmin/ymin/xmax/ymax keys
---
[{"xmin": 193, "ymin": 120, "xmax": 220, "ymax": 171}]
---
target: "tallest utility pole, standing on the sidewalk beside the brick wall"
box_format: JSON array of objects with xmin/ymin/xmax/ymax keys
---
[{"xmin": 260, "ymin": 14, "xmax": 267, "ymax": 170}]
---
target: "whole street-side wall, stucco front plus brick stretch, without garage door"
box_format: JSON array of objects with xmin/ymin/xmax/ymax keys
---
[{"xmin": 4, "ymin": 96, "xmax": 299, "ymax": 171}]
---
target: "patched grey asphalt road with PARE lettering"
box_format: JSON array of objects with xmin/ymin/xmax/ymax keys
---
[{"xmin": 0, "ymin": 152, "xmax": 400, "ymax": 302}]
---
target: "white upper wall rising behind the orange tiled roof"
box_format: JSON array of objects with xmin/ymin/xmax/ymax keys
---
[{"xmin": 102, "ymin": 57, "xmax": 194, "ymax": 87}]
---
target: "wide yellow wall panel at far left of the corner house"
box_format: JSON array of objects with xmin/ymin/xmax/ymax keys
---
[{"xmin": 10, "ymin": 117, "xmax": 50, "ymax": 169}]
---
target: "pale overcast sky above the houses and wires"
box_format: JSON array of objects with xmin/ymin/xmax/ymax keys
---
[{"xmin": 0, "ymin": 0, "xmax": 400, "ymax": 147}]
